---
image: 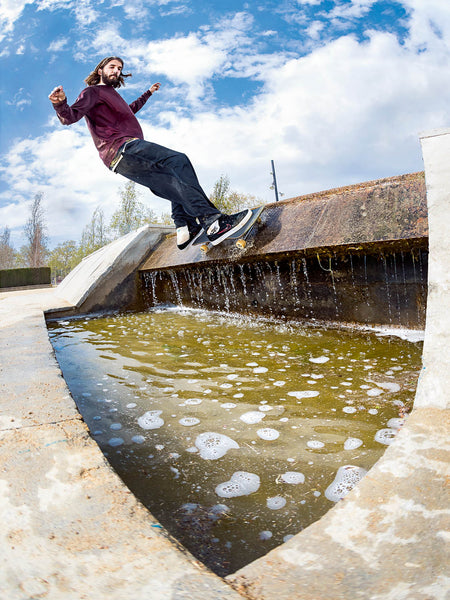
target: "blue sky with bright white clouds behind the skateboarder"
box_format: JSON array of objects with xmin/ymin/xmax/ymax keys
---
[{"xmin": 0, "ymin": 0, "xmax": 450, "ymax": 249}]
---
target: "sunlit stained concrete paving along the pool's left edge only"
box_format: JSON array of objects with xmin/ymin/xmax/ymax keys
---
[{"xmin": 0, "ymin": 290, "xmax": 240, "ymax": 600}]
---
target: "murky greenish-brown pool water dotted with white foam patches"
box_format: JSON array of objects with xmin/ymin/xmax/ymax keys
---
[{"xmin": 49, "ymin": 309, "xmax": 422, "ymax": 575}]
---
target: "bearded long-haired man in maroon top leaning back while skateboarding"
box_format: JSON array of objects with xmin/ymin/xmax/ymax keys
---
[{"xmin": 49, "ymin": 56, "xmax": 251, "ymax": 250}]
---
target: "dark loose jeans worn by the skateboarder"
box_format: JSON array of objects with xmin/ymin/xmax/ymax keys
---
[{"xmin": 114, "ymin": 140, "xmax": 221, "ymax": 227}]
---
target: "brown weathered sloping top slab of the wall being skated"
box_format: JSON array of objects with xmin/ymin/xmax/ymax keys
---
[{"xmin": 142, "ymin": 173, "xmax": 428, "ymax": 271}]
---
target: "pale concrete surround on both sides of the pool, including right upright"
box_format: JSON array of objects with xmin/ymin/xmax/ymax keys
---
[{"xmin": 0, "ymin": 130, "xmax": 450, "ymax": 600}]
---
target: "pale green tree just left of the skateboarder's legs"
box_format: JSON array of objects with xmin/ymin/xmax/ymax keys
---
[{"xmin": 110, "ymin": 181, "xmax": 149, "ymax": 237}]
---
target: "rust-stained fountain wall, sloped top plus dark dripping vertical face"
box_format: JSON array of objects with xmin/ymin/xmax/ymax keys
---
[{"xmin": 141, "ymin": 173, "xmax": 428, "ymax": 329}]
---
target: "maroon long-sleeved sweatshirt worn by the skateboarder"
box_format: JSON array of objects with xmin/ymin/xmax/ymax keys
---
[{"xmin": 53, "ymin": 85, "xmax": 152, "ymax": 167}]
